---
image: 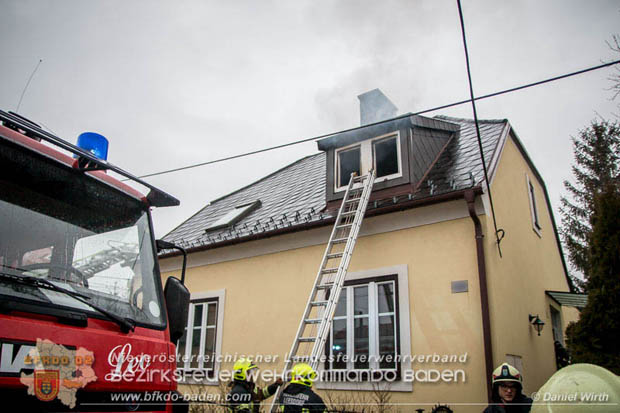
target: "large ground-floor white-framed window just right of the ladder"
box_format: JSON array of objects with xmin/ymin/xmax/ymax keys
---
[{"xmin": 317, "ymin": 265, "xmax": 413, "ymax": 391}]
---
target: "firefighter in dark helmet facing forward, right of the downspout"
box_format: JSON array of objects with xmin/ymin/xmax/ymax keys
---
[{"xmin": 483, "ymin": 363, "xmax": 532, "ymax": 413}]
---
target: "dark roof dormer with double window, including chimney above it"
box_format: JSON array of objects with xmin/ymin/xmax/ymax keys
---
[{"xmin": 318, "ymin": 89, "xmax": 460, "ymax": 204}]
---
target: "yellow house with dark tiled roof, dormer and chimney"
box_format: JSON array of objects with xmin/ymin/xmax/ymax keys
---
[{"xmin": 160, "ymin": 91, "xmax": 583, "ymax": 412}]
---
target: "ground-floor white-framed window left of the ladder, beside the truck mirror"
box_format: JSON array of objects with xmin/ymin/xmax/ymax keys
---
[{"xmin": 177, "ymin": 290, "xmax": 224, "ymax": 384}]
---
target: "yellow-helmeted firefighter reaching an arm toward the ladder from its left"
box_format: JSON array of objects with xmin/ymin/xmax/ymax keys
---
[{"xmin": 226, "ymin": 358, "xmax": 282, "ymax": 413}]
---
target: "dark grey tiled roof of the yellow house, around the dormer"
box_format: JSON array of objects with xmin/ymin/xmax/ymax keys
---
[{"xmin": 164, "ymin": 116, "xmax": 508, "ymax": 249}]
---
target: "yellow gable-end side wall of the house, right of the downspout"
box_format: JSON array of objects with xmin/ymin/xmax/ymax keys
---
[{"xmin": 483, "ymin": 136, "xmax": 578, "ymax": 393}]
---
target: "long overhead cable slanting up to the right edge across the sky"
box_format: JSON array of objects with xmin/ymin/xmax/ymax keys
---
[{"xmin": 138, "ymin": 60, "xmax": 620, "ymax": 178}]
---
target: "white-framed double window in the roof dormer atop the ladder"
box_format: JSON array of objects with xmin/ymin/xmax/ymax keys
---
[{"xmin": 334, "ymin": 132, "xmax": 402, "ymax": 192}]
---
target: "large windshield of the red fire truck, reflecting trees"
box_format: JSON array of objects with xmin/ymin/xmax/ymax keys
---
[{"xmin": 0, "ymin": 145, "xmax": 164, "ymax": 328}]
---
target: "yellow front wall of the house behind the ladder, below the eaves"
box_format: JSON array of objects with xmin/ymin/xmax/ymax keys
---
[{"xmin": 164, "ymin": 201, "xmax": 486, "ymax": 412}]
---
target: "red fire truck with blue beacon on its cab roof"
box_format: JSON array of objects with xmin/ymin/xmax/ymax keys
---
[{"xmin": 0, "ymin": 111, "xmax": 189, "ymax": 412}]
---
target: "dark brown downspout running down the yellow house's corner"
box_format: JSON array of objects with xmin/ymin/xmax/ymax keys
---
[{"xmin": 464, "ymin": 190, "xmax": 493, "ymax": 402}]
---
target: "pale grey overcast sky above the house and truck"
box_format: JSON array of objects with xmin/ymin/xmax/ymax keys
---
[{"xmin": 0, "ymin": 0, "xmax": 620, "ymax": 236}]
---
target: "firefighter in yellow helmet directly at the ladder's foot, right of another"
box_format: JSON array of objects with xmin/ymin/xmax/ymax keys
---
[{"xmin": 279, "ymin": 363, "xmax": 327, "ymax": 413}]
